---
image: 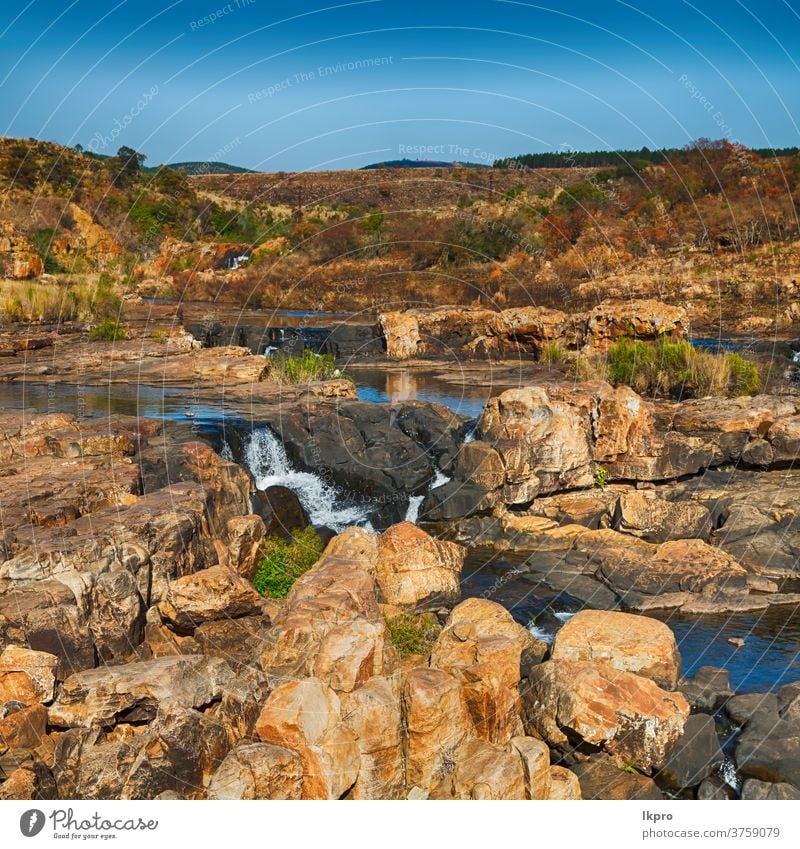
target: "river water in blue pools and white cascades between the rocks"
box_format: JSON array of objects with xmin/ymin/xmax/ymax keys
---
[{"xmin": 6, "ymin": 324, "xmax": 800, "ymax": 692}]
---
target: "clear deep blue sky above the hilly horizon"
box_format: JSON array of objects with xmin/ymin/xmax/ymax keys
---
[{"xmin": 0, "ymin": 0, "xmax": 800, "ymax": 171}]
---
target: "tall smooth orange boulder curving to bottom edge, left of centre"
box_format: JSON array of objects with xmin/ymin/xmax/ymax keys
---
[{"xmin": 255, "ymin": 678, "xmax": 360, "ymax": 799}]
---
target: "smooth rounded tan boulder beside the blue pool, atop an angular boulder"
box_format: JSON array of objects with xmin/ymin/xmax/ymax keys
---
[{"xmin": 551, "ymin": 610, "xmax": 681, "ymax": 690}]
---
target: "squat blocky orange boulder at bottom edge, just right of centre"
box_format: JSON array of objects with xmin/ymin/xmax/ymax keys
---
[{"xmin": 453, "ymin": 740, "xmax": 526, "ymax": 799}]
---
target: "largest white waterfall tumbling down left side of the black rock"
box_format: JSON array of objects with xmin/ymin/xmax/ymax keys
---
[{"xmin": 245, "ymin": 428, "xmax": 371, "ymax": 533}]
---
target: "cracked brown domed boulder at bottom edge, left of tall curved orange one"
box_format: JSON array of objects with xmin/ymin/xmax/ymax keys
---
[{"xmin": 208, "ymin": 743, "xmax": 303, "ymax": 799}]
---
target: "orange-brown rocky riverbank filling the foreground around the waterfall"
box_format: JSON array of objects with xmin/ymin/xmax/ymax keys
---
[{"xmin": 0, "ymin": 308, "xmax": 800, "ymax": 799}]
